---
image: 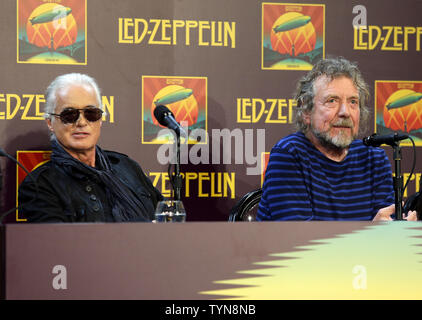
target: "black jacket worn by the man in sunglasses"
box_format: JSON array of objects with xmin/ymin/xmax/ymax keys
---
[{"xmin": 18, "ymin": 151, "xmax": 163, "ymax": 222}]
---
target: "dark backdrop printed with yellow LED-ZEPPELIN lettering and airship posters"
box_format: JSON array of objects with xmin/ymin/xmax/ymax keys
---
[{"xmin": 0, "ymin": 0, "xmax": 422, "ymax": 222}]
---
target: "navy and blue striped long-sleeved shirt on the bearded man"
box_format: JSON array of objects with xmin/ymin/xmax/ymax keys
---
[{"xmin": 257, "ymin": 132, "xmax": 394, "ymax": 221}]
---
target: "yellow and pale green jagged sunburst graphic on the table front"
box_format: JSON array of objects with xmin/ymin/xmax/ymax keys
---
[{"xmin": 200, "ymin": 222, "xmax": 422, "ymax": 300}]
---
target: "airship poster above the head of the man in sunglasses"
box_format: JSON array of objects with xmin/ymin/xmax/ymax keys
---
[{"xmin": 17, "ymin": 0, "xmax": 87, "ymax": 65}]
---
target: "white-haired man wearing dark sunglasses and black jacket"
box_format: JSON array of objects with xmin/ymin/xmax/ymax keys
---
[{"xmin": 19, "ymin": 73, "xmax": 163, "ymax": 222}]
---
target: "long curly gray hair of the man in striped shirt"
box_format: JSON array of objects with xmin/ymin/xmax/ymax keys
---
[{"xmin": 295, "ymin": 57, "xmax": 369, "ymax": 133}]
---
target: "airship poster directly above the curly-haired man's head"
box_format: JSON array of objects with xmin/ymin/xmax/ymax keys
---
[{"xmin": 261, "ymin": 3, "xmax": 325, "ymax": 70}]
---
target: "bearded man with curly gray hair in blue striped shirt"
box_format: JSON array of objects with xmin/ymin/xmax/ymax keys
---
[{"xmin": 257, "ymin": 58, "xmax": 416, "ymax": 220}]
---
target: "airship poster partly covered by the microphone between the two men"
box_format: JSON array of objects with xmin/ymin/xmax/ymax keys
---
[{"xmin": 142, "ymin": 76, "xmax": 207, "ymax": 144}]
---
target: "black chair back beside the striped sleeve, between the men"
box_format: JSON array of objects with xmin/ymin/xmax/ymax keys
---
[{"xmin": 229, "ymin": 188, "xmax": 262, "ymax": 222}]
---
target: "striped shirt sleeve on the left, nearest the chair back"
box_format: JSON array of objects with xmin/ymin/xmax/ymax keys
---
[{"xmin": 257, "ymin": 147, "xmax": 313, "ymax": 221}]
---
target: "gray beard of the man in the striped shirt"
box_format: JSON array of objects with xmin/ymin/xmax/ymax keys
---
[{"xmin": 310, "ymin": 118, "xmax": 357, "ymax": 151}]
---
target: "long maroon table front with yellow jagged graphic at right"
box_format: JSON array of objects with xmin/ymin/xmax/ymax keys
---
[{"xmin": 0, "ymin": 221, "xmax": 422, "ymax": 300}]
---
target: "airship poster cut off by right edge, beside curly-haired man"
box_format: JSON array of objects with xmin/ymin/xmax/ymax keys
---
[{"xmin": 375, "ymin": 81, "xmax": 422, "ymax": 146}]
